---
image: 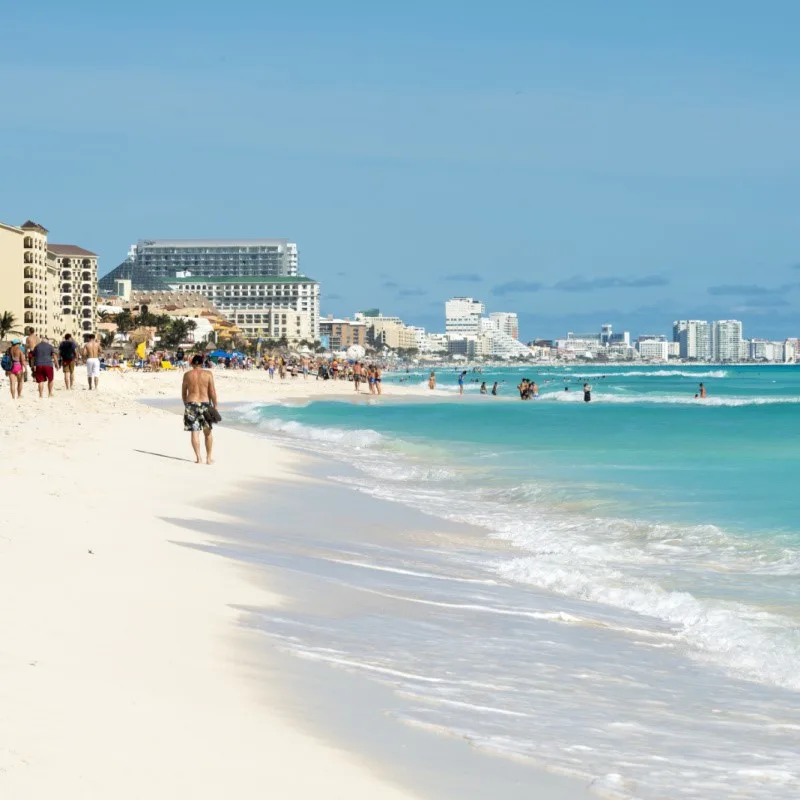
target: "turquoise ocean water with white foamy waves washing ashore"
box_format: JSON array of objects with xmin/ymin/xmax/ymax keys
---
[{"xmin": 230, "ymin": 366, "xmax": 800, "ymax": 798}]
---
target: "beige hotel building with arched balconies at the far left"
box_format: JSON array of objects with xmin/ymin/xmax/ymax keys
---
[{"xmin": 0, "ymin": 220, "xmax": 97, "ymax": 342}]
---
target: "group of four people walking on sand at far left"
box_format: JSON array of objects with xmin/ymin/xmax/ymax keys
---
[{"xmin": 0, "ymin": 329, "xmax": 101, "ymax": 400}]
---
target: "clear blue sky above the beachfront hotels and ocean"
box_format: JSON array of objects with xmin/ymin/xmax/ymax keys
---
[{"xmin": 0, "ymin": 0, "xmax": 800, "ymax": 338}]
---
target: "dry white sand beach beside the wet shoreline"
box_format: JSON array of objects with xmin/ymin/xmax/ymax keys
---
[{"xmin": 0, "ymin": 369, "xmax": 578, "ymax": 800}]
